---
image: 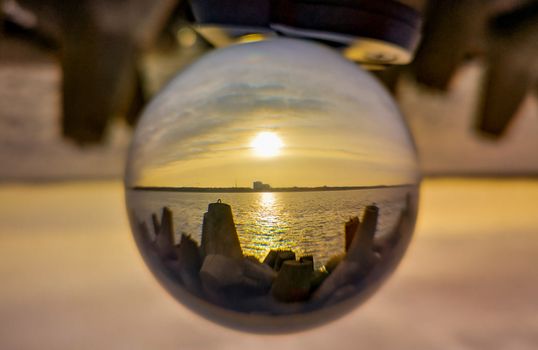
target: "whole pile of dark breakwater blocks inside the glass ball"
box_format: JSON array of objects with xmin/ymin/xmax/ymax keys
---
[{"xmin": 134, "ymin": 200, "xmax": 408, "ymax": 314}]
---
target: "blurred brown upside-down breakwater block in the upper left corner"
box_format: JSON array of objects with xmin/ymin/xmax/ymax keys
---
[{"xmin": 3, "ymin": 0, "xmax": 184, "ymax": 145}]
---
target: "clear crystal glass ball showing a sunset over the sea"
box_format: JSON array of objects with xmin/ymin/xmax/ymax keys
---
[{"xmin": 125, "ymin": 39, "xmax": 420, "ymax": 333}]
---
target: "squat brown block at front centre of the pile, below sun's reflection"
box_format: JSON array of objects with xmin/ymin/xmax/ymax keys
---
[{"xmin": 271, "ymin": 260, "xmax": 313, "ymax": 302}]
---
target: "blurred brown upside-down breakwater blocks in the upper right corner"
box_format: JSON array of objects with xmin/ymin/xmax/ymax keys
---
[{"xmin": 406, "ymin": 0, "xmax": 538, "ymax": 138}]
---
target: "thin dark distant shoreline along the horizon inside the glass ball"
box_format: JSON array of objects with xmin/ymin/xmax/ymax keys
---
[{"xmin": 130, "ymin": 184, "xmax": 415, "ymax": 193}]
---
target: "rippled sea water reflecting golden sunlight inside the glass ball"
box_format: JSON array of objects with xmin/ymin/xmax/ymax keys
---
[{"xmin": 127, "ymin": 185, "xmax": 416, "ymax": 267}]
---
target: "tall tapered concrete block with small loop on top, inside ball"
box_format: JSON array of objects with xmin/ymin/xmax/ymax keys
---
[{"xmin": 201, "ymin": 201, "xmax": 243, "ymax": 258}]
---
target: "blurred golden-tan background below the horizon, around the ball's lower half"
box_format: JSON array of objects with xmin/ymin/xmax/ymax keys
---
[{"xmin": 0, "ymin": 179, "xmax": 538, "ymax": 350}]
